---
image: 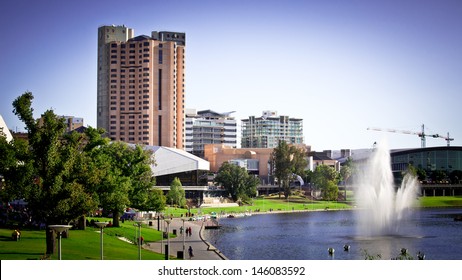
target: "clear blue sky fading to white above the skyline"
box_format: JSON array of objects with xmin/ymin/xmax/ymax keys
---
[{"xmin": 0, "ymin": 0, "xmax": 462, "ymax": 150}]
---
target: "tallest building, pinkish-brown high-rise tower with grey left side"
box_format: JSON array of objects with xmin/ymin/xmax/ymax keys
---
[{"xmin": 97, "ymin": 26, "xmax": 186, "ymax": 149}]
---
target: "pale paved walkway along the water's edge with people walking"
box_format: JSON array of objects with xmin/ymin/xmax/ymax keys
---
[{"xmin": 143, "ymin": 218, "xmax": 227, "ymax": 260}]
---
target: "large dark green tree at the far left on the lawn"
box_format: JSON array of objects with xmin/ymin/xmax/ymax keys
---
[{"xmin": 0, "ymin": 92, "xmax": 96, "ymax": 254}]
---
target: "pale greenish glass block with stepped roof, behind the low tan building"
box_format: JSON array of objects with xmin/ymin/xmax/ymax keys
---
[{"xmin": 241, "ymin": 111, "xmax": 304, "ymax": 148}]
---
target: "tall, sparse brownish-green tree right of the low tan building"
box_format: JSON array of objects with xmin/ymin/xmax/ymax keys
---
[{"xmin": 270, "ymin": 140, "xmax": 307, "ymax": 198}]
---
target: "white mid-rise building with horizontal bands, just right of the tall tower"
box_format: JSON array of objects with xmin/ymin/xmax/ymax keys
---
[{"xmin": 185, "ymin": 109, "xmax": 237, "ymax": 158}]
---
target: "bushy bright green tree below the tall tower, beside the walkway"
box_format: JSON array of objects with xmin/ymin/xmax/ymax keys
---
[{"xmin": 78, "ymin": 127, "xmax": 165, "ymax": 226}]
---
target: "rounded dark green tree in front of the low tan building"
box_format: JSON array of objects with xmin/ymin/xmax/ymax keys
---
[{"xmin": 215, "ymin": 162, "xmax": 260, "ymax": 201}]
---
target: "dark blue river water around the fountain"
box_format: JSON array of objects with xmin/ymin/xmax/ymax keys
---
[{"xmin": 205, "ymin": 208, "xmax": 462, "ymax": 260}]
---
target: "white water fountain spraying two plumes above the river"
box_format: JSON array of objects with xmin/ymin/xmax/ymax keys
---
[{"xmin": 355, "ymin": 142, "xmax": 418, "ymax": 237}]
